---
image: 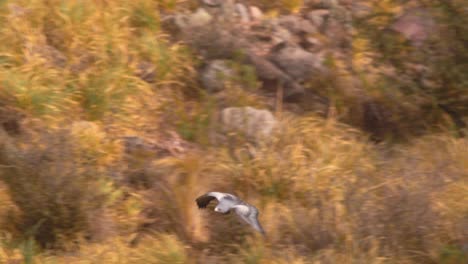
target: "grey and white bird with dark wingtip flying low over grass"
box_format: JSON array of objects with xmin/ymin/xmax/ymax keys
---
[{"xmin": 196, "ymin": 192, "xmax": 265, "ymax": 235}]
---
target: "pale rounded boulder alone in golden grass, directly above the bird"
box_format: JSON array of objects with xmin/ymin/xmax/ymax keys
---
[{"xmin": 221, "ymin": 106, "xmax": 277, "ymax": 142}]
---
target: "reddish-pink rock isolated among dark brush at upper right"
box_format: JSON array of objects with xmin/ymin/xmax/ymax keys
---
[{"xmin": 390, "ymin": 9, "xmax": 435, "ymax": 46}]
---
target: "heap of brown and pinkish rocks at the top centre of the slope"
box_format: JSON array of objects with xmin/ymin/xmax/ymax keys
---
[{"xmin": 166, "ymin": 0, "xmax": 348, "ymax": 106}]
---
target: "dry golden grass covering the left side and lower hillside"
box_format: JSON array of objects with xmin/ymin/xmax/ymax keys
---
[{"xmin": 0, "ymin": 0, "xmax": 468, "ymax": 264}]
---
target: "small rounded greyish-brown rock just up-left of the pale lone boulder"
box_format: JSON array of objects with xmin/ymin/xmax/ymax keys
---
[{"xmin": 201, "ymin": 60, "xmax": 234, "ymax": 92}]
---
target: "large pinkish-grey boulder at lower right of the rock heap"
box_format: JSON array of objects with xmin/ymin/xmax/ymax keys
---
[{"xmin": 270, "ymin": 45, "xmax": 322, "ymax": 82}]
